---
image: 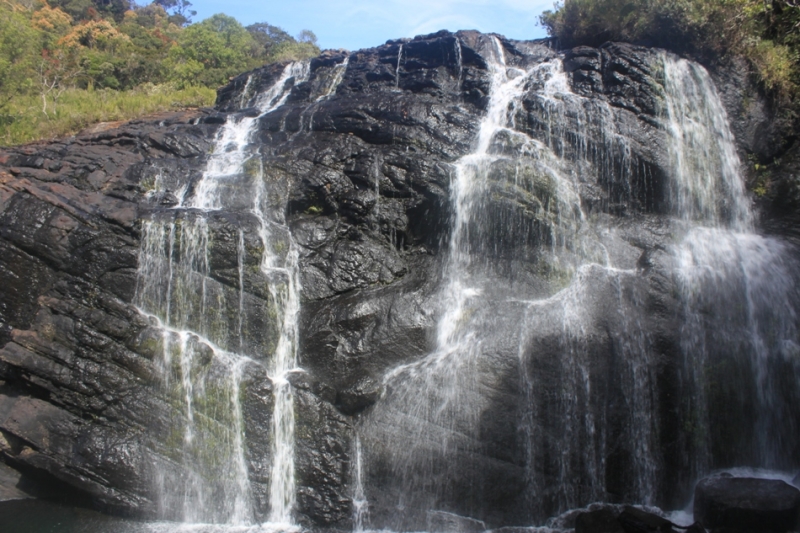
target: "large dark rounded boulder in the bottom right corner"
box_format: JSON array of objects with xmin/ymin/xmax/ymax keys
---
[{"xmin": 694, "ymin": 475, "xmax": 800, "ymax": 532}]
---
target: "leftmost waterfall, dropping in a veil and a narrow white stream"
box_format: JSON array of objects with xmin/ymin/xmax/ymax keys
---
[{"xmin": 136, "ymin": 63, "xmax": 309, "ymax": 528}]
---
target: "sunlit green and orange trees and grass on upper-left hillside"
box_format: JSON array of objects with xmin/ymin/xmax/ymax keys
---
[{"xmin": 0, "ymin": 0, "xmax": 319, "ymax": 145}]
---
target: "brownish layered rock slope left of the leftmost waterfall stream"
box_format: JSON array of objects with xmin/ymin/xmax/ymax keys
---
[{"xmin": 0, "ymin": 113, "xmax": 217, "ymax": 512}]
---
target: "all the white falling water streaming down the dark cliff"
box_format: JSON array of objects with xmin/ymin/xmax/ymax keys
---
[{"xmin": 137, "ymin": 38, "xmax": 798, "ymax": 532}]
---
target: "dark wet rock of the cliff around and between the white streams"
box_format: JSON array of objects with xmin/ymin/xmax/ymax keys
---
[{"xmin": 0, "ymin": 32, "xmax": 800, "ymax": 532}]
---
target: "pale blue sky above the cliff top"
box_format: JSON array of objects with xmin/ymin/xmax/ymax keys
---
[{"xmin": 191, "ymin": 0, "xmax": 554, "ymax": 50}]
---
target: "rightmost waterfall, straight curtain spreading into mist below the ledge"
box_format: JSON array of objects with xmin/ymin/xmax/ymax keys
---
[{"xmin": 661, "ymin": 53, "xmax": 800, "ymax": 470}]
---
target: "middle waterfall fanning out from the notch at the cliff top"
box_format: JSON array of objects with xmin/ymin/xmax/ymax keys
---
[{"xmin": 363, "ymin": 40, "xmax": 648, "ymax": 529}]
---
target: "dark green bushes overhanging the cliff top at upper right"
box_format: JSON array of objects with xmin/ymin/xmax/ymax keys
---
[{"xmin": 540, "ymin": 0, "xmax": 800, "ymax": 99}]
